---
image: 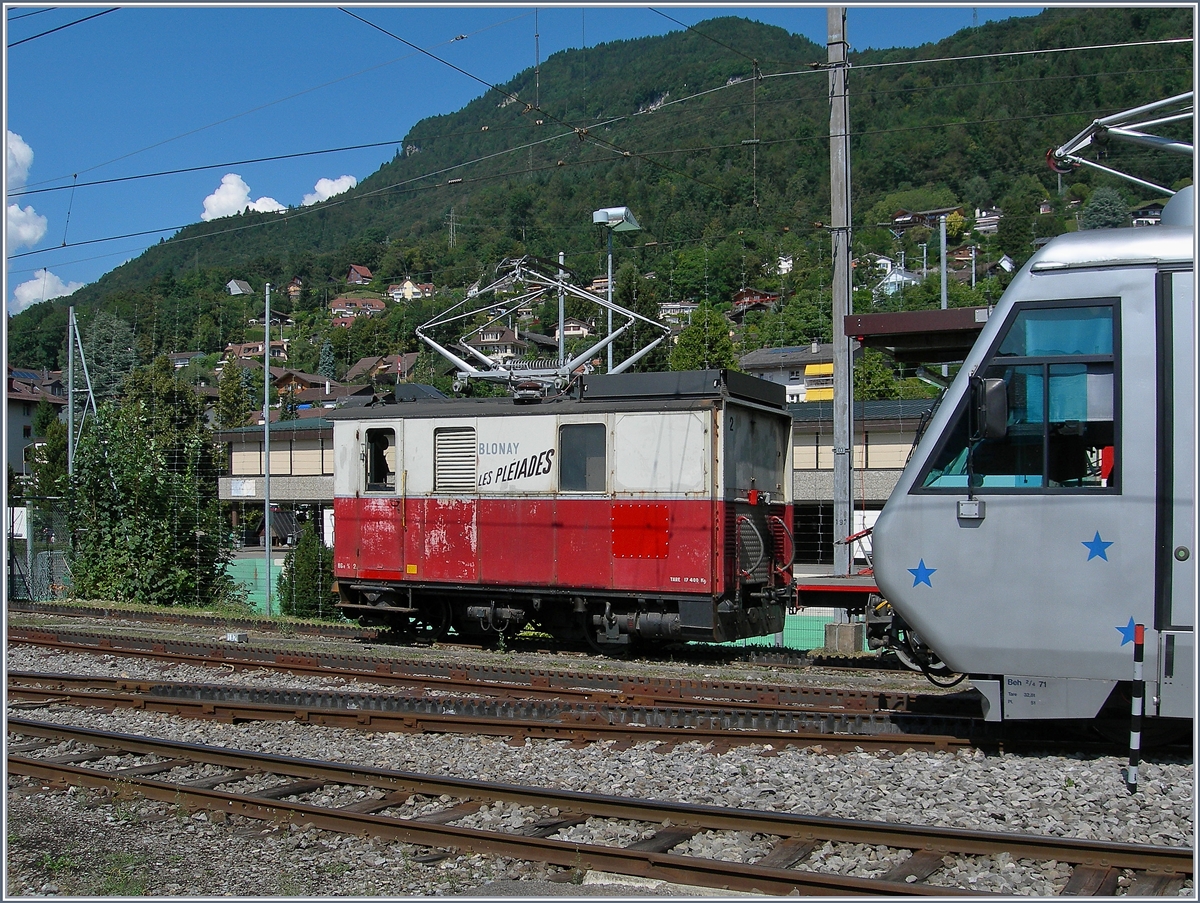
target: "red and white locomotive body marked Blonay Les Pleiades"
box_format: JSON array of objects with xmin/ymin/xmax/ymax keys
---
[{"xmin": 330, "ymin": 370, "xmax": 794, "ymax": 647}]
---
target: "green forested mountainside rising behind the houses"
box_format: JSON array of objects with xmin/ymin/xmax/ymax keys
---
[{"xmin": 8, "ymin": 7, "xmax": 1193, "ymax": 370}]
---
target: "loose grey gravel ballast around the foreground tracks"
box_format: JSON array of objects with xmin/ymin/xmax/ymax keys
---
[{"xmin": 6, "ymin": 645, "xmax": 1194, "ymax": 896}]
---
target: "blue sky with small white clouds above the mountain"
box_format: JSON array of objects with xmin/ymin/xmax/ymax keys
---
[{"xmin": 5, "ymin": 5, "xmax": 1040, "ymax": 312}]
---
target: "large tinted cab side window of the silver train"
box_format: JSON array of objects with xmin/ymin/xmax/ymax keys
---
[{"xmin": 920, "ymin": 304, "xmax": 1117, "ymax": 490}]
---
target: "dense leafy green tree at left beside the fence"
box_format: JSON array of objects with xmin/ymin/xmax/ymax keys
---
[{"xmin": 70, "ymin": 357, "xmax": 233, "ymax": 605}]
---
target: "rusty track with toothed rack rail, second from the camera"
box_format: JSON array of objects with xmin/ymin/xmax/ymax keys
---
[{"xmin": 7, "ymin": 672, "xmax": 970, "ymax": 750}]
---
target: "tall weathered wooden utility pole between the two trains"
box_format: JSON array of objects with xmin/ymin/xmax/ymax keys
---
[{"xmin": 828, "ymin": 6, "xmax": 854, "ymax": 575}]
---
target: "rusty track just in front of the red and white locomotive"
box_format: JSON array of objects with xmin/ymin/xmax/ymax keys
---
[{"xmin": 8, "ymin": 628, "xmax": 979, "ymax": 717}]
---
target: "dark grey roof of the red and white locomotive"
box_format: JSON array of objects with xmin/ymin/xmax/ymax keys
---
[{"xmin": 326, "ymin": 370, "xmax": 791, "ymax": 420}]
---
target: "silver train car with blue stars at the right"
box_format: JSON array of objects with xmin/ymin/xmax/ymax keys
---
[{"xmin": 874, "ymin": 189, "xmax": 1196, "ymax": 720}]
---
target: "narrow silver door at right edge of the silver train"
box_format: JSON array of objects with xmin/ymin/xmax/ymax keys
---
[{"xmin": 1154, "ymin": 273, "xmax": 1196, "ymax": 718}]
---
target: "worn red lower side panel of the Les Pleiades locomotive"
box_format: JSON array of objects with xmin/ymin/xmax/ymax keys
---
[{"xmin": 334, "ymin": 497, "xmax": 791, "ymax": 597}]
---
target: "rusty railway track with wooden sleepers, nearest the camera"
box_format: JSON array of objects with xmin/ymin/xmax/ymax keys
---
[{"xmin": 7, "ymin": 718, "xmax": 1193, "ymax": 896}]
